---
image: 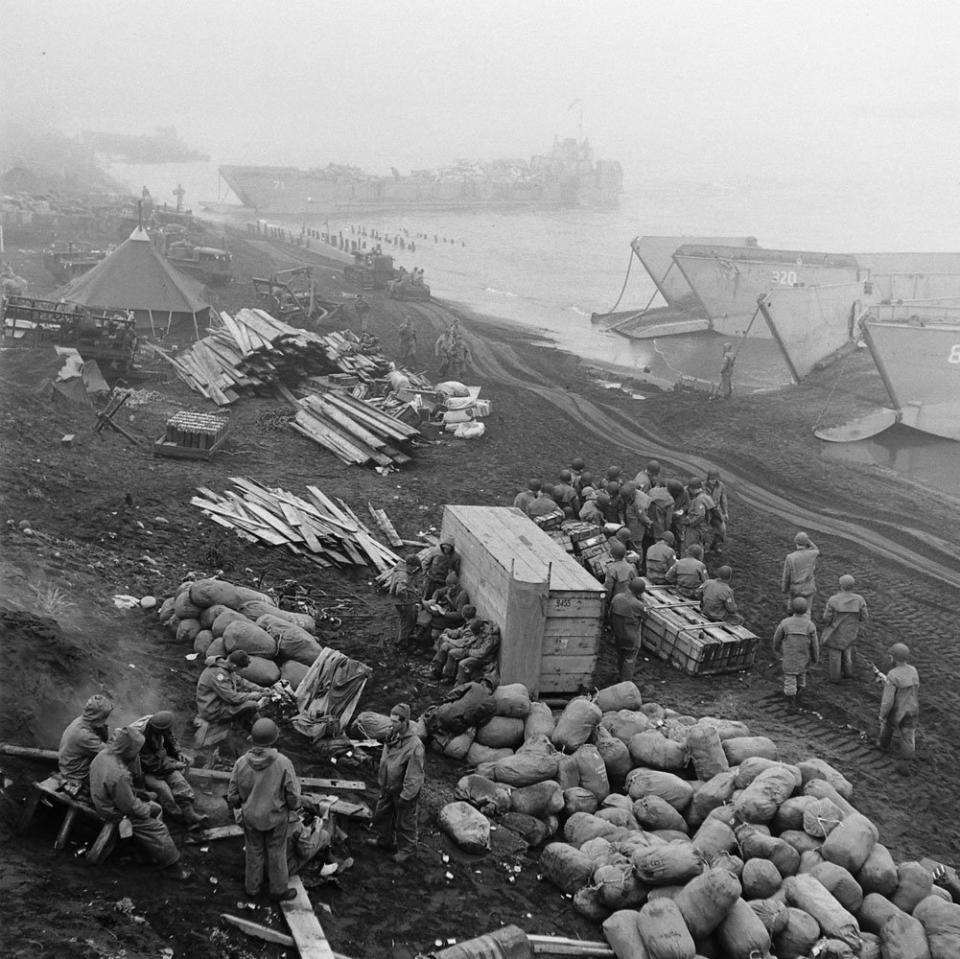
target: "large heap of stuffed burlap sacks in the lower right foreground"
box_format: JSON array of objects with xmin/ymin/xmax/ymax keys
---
[{"xmin": 362, "ymin": 682, "xmax": 960, "ymax": 959}]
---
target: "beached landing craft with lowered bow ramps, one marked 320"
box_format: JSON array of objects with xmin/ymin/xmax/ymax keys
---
[{"xmin": 591, "ymin": 236, "xmax": 960, "ymax": 439}]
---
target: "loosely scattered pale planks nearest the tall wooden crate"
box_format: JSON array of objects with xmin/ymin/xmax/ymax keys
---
[{"xmin": 190, "ymin": 476, "xmax": 400, "ymax": 572}]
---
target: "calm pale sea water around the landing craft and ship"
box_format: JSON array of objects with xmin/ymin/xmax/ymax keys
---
[{"xmin": 112, "ymin": 163, "xmax": 960, "ymax": 488}]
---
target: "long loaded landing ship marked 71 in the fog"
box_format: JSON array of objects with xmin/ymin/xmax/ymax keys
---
[{"xmin": 220, "ymin": 138, "xmax": 623, "ymax": 215}]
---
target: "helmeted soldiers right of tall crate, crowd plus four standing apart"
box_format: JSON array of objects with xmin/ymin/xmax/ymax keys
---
[{"xmin": 513, "ymin": 458, "xmax": 919, "ymax": 760}]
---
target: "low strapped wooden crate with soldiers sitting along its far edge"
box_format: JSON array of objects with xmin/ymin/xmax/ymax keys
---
[{"xmin": 641, "ymin": 580, "xmax": 760, "ymax": 676}]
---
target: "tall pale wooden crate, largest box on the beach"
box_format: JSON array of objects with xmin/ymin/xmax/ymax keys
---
[{"xmin": 441, "ymin": 506, "xmax": 604, "ymax": 695}]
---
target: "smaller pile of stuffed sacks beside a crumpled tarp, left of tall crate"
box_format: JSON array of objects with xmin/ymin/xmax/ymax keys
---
[{"xmin": 157, "ymin": 579, "xmax": 323, "ymax": 689}]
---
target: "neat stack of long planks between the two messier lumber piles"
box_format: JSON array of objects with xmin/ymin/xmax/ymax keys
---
[{"xmin": 280, "ymin": 387, "xmax": 420, "ymax": 467}]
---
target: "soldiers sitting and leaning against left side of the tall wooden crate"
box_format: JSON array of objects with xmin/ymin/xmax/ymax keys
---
[{"xmin": 389, "ymin": 540, "xmax": 500, "ymax": 685}]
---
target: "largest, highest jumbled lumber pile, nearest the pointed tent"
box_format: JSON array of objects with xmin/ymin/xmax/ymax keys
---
[{"xmin": 150, "ymin": 309, "xmax": 390, "ymax": 406}]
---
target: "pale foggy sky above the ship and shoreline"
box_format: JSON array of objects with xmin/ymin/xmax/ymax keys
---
[{"xmin": 0, "ymin": 0, "xmax": 960, "ymax": 181}]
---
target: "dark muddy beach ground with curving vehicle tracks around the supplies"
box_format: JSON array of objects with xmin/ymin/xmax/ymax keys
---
[{"xmin": 0, "ymin": 225, "xmax": 960, "ymax": 959}]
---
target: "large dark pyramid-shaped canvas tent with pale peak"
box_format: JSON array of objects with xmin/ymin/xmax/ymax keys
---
[{"xmin": 55, "ymin": 227, "xmax": 210, "ymax": 336}]
